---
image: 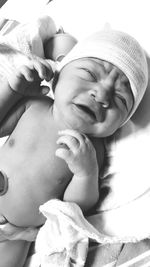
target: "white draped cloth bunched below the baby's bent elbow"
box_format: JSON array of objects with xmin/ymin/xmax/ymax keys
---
[{"xmin": 35, "ymin": 199, "xmax": 139, "ymax": 267}]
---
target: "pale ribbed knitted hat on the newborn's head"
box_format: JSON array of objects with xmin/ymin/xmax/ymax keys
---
[{"xmin": 58, "ymin": 29, "xmax": 148, "ymax": 123}]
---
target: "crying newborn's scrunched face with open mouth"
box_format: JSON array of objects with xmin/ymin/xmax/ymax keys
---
[{"xmin": 54, "ymin": 58, "xmax": 133, "ymax": 137}]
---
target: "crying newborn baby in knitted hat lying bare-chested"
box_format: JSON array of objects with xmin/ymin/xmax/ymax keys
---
[{"xmin": 0, "ymin": 25, "xmax": 148, "ymax": 267}]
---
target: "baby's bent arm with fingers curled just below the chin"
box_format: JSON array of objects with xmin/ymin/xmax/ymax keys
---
[{"xmin": 56, "ymin": 130, "xmax": 99, "ymax": 214}]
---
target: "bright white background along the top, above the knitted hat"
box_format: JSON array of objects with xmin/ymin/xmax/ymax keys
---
[{"xmin": 0, "ymin": 0, "xmax": 150, "ymax": 50}]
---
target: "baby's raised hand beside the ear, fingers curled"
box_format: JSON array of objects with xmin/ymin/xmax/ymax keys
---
[{"xmin": 7, "ymin": 57, "xmax": 53, "ymax": 96}]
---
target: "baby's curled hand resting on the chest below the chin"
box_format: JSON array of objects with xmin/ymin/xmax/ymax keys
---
[{"xmin": 56, "ymin": 129, "xmax": 98, "ymax": 177}]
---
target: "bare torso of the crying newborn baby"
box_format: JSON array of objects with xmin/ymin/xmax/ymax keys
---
[{"xmin": 0, "ymin": 98, "xmax": 72, "ymax": 226}]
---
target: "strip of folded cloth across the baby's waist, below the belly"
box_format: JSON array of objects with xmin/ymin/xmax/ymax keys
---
[{"xmin": 0, "ymin": 222, "xmax": 39, "ymax": 242}]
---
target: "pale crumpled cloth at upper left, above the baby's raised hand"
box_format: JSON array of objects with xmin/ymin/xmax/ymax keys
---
[{"xmin": 0, "ymin": 16, "xmax": 57, "ymax": 80}]
